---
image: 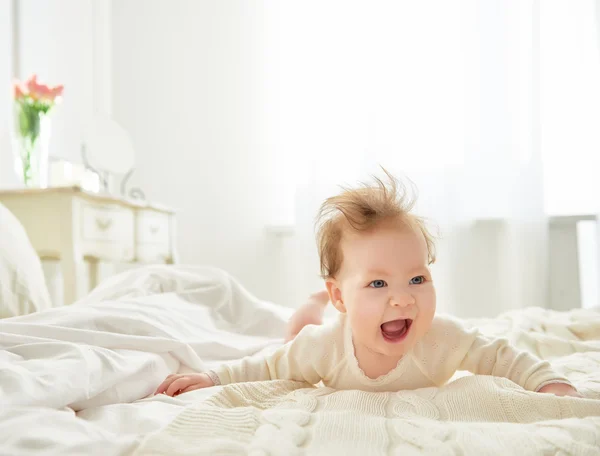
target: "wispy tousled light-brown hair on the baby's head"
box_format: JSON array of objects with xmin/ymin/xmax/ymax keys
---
[{"xmin": 316, "ymin": 168, "xmax": 435, "ymax": 279}]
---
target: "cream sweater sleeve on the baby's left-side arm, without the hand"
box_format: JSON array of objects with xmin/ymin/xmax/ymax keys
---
[{"xmin": 209, "ymin": 325, "xmax": 335, "ymax": 385}]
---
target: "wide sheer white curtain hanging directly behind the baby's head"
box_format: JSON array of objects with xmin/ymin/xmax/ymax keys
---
[{"xmin": 267, "ymin": 0, "xmax": 548, "ymax": 315}]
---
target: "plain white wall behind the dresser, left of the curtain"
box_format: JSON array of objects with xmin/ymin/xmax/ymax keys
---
[{"xmin": 0, "ymin": 0, "xmax": 304, "ymax": 304}]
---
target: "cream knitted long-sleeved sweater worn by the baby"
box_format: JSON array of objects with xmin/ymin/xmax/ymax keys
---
[{"xmin": 213, "ymin": 314, "xmax": 569, "ymax": 392}]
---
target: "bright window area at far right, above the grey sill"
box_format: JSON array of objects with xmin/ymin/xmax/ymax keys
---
[{"xmin": 540, "ymin": 0, "xmax": 600, "ymax": 215}]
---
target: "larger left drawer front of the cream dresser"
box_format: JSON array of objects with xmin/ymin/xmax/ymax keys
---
[{"xmin": 81, "ymin": 205, "xmax": 134, "ymax": 242}]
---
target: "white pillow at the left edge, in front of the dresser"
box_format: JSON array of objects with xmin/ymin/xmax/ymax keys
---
[{"xmin": 0, "ymin": 204, "xmax": 52, "ymax": 318}]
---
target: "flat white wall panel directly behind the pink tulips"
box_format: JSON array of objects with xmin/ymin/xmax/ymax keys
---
[{"xmin": 16, "ymin": 0, "xmax": 94, "ymax": 166}]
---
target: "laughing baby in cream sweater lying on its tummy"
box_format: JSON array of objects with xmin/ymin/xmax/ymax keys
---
[{"xmin": 156, "ymin": 172, "xmax": 581, "ymax": 397}]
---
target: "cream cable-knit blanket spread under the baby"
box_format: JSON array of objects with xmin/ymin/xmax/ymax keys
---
[{"xmin": 135, "ymin": 309, "xmax": 600, "ymax": 456}]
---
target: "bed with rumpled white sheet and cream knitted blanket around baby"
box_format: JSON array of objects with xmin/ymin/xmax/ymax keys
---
[{"xmin": 0, "ymin": 208, "xmax": 600, "ymax": 456}]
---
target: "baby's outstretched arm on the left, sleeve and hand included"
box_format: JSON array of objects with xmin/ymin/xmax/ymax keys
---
[{"xmin": 155, "ymin": 325, "xmax": 331, "ymax": 396}]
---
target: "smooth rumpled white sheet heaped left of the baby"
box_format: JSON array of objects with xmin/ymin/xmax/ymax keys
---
[{"xmin": 0, "ymin": 267, "xmax": 291, "ymax": 456}]
